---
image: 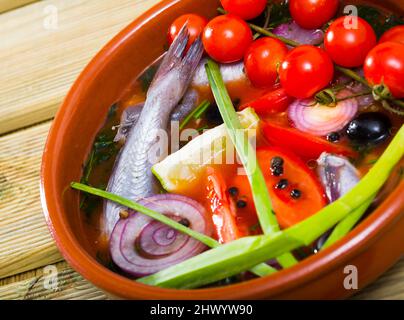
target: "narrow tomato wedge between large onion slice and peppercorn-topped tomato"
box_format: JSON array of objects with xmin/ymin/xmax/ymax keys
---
[{"xmin": 206, "ymin": 167, "xmax": 248, "ymax": 243}]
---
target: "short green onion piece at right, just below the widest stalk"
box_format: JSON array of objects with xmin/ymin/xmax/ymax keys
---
[{"xmin": 321, "ymin": 197, "xmax": 374, "ymax": 250}]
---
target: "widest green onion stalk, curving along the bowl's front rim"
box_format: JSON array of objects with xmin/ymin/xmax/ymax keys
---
[{"xmin": 138, "ymin": 126, "xmax": 404, "ymax": 288}]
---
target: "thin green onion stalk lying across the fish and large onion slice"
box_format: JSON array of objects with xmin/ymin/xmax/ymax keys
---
[{"xmin": 71, "ymin": 182, "xmax": 277, "ymax": 277}]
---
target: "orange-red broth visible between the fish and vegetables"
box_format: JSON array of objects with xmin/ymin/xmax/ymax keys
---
[{"xmin": 78, "ymin": 1, "xmax": 403, "ymax": 284}]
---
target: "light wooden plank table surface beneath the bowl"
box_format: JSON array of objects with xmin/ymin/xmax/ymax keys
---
[{"xmin": 0, "ymin": 0, "xmax": 404, "ymax": 299}]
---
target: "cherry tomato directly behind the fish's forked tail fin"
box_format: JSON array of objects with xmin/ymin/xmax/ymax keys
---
[{"xmin": 168, "ymin": 13, "xmax": 208, "ymax": 48}]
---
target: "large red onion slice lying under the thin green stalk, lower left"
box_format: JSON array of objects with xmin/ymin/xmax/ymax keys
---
[{"xmin": 110, "ymin": 194, "xmax": 213, "ymax": 277}]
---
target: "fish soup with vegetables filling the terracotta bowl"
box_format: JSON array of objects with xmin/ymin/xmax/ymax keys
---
[{"xmin": 74, "ymin": 0, "xmax": 404, "ymax": 288}]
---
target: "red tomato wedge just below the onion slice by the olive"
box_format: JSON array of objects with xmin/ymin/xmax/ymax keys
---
[{"xmin": 262, "ymin": 122, "xmax": 357, "ymax": 160}]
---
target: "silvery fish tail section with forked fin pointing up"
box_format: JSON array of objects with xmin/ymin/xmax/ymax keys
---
[{"xmin": 103, "ymin": 26, "xmax": 203, "ymax": 235}]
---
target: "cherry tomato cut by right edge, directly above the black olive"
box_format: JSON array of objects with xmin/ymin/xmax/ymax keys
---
[{"xmin": 363, "ymin": 42, "xmax": 404, "ymax": 99}]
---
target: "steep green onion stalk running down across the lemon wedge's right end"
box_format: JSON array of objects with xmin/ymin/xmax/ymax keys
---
[{"xmin": 205, "ymin": 60, "xmax": 297, "ymax": 267}]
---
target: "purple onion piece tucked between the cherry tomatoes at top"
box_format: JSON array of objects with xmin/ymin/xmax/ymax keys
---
[{"xmin": 272, "ymin": 21, "xmax": 324, "ymax": 45}]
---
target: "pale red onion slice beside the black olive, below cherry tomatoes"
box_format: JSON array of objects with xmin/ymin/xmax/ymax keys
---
[{"xmin": 288, "ymin": 90, "xmax": 358, "ymax": 136}]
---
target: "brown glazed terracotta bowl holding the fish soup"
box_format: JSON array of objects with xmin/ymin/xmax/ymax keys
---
[{"xmin": 41, "ymin": 0, "xmax": 404, "ymax": 299}]
